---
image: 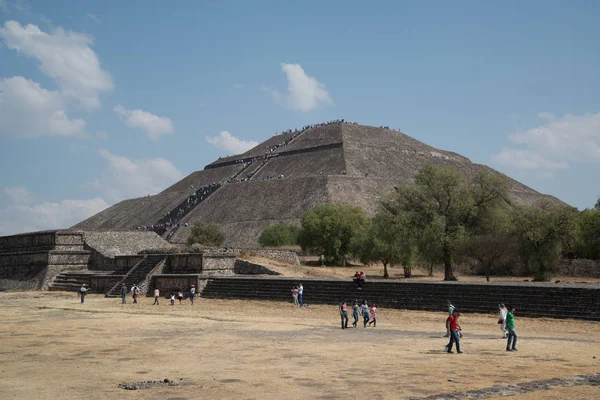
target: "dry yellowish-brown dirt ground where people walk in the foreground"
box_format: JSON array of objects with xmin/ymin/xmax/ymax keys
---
[{"xmin": 0, "ymin": 292, "xmax": 600, "ymax": 400}]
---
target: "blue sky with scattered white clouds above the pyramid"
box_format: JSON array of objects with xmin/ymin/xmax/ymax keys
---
[{"xmin": 0, "ymin": 0, "xmax": 600, "ymax": 234}]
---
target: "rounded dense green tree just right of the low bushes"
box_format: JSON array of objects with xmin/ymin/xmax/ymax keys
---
[{"xmin": 298, "ymin": 204, "xmax": 369, "ymax": 265}]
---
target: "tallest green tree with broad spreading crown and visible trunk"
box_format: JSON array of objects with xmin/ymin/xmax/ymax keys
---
[{"xmin": 383, "ymin": 164, "xmax": 509, "ymax": 280}]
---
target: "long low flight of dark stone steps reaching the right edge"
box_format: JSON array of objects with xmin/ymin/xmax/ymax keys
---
[{"xmin": 202, "ymin": 277, "xmax": 600, "ymax": 321}]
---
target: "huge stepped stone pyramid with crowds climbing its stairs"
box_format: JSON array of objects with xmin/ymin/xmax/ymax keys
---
[{"xmin": 72, "ymin": 122, "xmax": 561, "ymax": 248}]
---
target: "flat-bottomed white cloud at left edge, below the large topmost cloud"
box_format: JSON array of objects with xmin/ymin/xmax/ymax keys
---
[{"xmin": 0, "ymin": 76, "xmax": 85, "ymax": 138}]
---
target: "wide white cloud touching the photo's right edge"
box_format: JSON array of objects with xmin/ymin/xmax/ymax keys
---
[{"xmin": 493, "ymin": 113, "xmax": 600, "ymax": 170}]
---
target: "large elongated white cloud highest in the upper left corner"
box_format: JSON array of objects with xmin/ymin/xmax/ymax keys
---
[{"xmin": 0, "ymin": 21, "xmax": 113, "ymax": 109}]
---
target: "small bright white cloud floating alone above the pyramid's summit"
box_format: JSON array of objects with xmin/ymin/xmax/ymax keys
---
[{"xmin": 270, "ymin": 63, "xmax": 333, "ymax": 111}]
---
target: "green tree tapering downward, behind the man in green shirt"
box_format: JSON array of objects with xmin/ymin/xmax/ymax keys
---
[{"xmin": 513, "ymin": 201, "xmax": 579, "ymax": 281}]
